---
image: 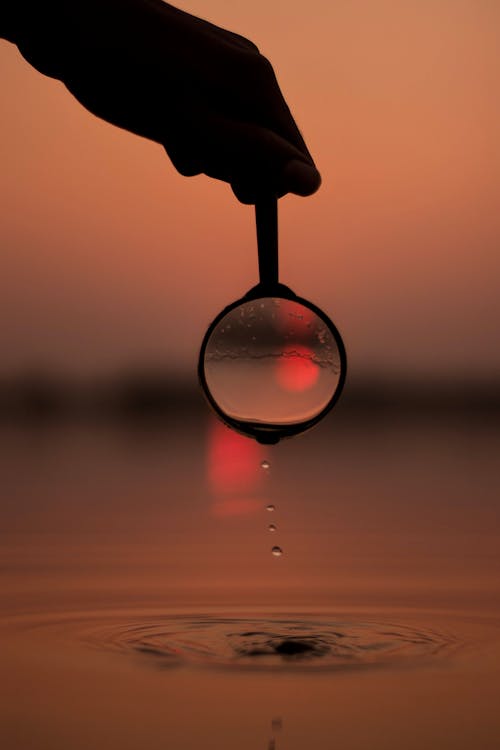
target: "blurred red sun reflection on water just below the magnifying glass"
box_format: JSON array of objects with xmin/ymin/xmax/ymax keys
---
[{"xmin": 207, "ymin": 419, "xmax": 264, "ymax": 517}]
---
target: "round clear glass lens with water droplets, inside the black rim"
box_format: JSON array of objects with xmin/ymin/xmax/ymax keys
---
[{"xmin": 204, "ymin": 297, "xmax": 341, "ymax": 426}]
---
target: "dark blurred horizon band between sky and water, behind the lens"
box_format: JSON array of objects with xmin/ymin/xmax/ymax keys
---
[{"xmin": 0, "ymin": 370, "xmax": 500, "ymax": 423}]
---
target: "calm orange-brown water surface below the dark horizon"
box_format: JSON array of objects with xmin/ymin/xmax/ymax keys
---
[{"xmin": 0, "ymin": 410, "xmax": 500, "ymax": 750}]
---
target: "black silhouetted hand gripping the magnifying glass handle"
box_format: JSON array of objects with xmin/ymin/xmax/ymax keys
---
[{"xmin": 0, "ymin": 0, "xmax": 320, "ymax": 203}]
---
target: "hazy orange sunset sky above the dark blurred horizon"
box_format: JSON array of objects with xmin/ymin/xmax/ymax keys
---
[{"xmin": 0, "ymin": 0, "xmax": 500, "ymax": 376}]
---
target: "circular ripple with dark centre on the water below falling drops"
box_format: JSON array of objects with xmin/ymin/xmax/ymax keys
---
[{"xmin": 79, "ymin": 616, "xmax": 457, "ymax": 669}]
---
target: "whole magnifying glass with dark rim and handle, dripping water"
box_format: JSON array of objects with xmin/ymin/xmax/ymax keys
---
[{"xmin": 198, "ymin": 197, "xmax": 347, "ymax": 444}]
